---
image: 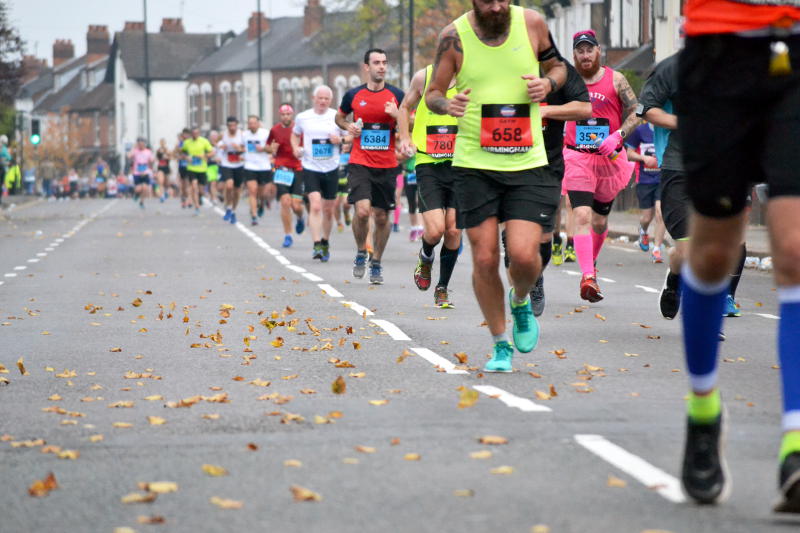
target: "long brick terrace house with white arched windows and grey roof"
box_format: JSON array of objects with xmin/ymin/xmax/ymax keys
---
[{"xmin": 185, "ymin": 0, "xmax": 390, "ymax": 129}]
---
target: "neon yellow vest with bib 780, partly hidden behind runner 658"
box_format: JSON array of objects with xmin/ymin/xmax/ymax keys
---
[{"xmin": 411, "ymin": 65, "xmax": 458, "ymax": 165}]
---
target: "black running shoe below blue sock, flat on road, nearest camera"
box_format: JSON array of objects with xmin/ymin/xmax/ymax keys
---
[{"xmin": 681, "ymin": 414, "xmax": 731, "ymax": 504}]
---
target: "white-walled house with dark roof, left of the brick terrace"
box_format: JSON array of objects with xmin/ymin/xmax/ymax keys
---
[{"xmin": 105, "ymin": 18, "xmax": 222, "ymax": 166}]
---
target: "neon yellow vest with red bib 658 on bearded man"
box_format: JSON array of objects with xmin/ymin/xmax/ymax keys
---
[{"xmin": 453, "ymin": 6, "xmax": 547, "ymax": 172}]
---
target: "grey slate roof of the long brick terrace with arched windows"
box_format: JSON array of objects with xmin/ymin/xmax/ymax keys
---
[{"xmin": 190, "ymin": 12, "xmax": 358, "ymax": 74}]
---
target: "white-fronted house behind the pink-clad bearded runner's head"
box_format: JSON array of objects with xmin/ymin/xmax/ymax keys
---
[{"xmin": 542, "ymin": 0, "xmax": 656, "ymax": 75}]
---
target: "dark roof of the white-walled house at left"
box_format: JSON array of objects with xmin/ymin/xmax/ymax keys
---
[{"xmin": 106, "ymin": 32, "xmax": 219, "ymax": 81}]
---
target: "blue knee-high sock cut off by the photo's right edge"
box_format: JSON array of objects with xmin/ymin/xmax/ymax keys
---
[{"xmin": 778, "ymin": 285, "xmax": 800, "ymax": 431}]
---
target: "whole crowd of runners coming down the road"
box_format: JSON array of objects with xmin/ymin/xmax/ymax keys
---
[{"xmin": 117, "ymin": 0, "xmax": 800, "ymax": 513}]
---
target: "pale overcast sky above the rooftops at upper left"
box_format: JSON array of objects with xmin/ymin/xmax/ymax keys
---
[{"xmin": 9, "ymin": 0, "xmax": 316, "ymax": 64}]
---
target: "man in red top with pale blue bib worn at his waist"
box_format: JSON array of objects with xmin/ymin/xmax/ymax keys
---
[{"xmin": 267, "ymin": 104, "xmax": 306, "ymax": 248}]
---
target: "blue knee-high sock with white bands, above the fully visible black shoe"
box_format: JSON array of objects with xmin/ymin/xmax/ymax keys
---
[{"xmin": 681, "ymin": 262, "xmax": 730, "ymax": 393}]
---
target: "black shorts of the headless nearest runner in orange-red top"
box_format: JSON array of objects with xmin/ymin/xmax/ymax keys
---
[{"xmin": 676, "ymin": 35, "xmax": 800, "ymax": 218}]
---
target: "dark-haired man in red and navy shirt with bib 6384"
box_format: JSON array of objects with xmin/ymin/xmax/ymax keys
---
[{"xmin": 336, "ymin": 48, "xmax": 403, "ymax": 285}]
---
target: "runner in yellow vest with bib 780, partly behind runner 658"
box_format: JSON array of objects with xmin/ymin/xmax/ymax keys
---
[{"xmin": 398, "ymin": 65, "xmax": 461, "ymax": 309}]
